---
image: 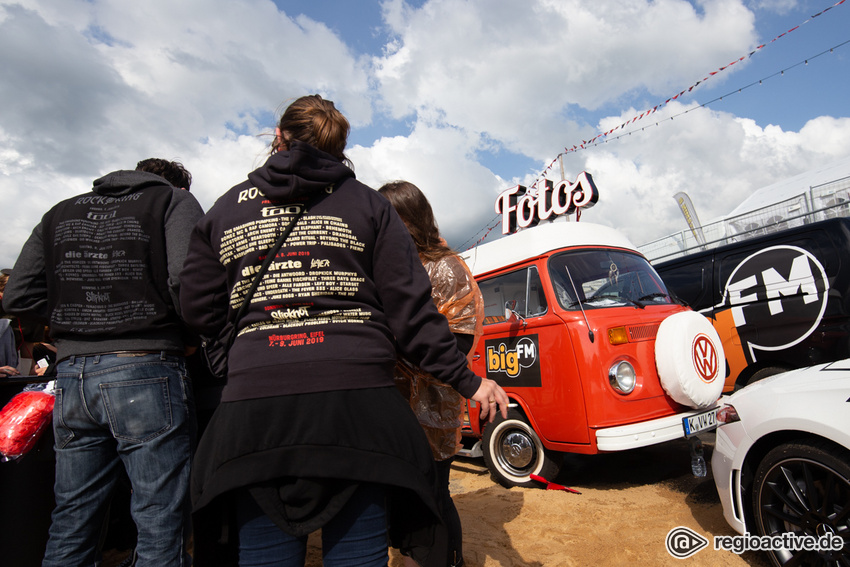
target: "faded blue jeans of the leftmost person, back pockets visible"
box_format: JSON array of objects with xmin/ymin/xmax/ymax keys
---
[{"xmin": 43, "ymin": 353, "xmax": 195, "ymax": 567}]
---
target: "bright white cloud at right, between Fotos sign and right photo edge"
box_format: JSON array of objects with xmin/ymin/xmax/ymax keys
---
[{"xmin": 568, "ymin": 103, "xmax": 850, "ymax": 245}]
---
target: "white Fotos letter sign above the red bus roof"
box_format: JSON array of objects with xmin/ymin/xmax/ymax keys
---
[{"xmin": 496, "ymin": 171, "xmax": 599, "ymax": 234}]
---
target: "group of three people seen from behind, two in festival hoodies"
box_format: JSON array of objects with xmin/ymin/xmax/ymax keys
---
[{"xmin": 0, "ymin": 95, "xmax": 508, "ymax": 567}]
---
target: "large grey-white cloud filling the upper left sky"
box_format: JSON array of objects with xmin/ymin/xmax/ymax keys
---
[{"xmin": 0, "ymin": 0, "xmax": 372, "ymax": 264}]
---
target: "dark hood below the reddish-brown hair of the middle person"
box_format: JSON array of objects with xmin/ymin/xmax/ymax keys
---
[{"xmin": 248, "ymin": 140, "xmax": 354, "ymax": 203}]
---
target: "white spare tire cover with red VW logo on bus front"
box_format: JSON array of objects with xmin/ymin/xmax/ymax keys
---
[{"xmin": 655, "ymin": 311, "xmax": 726, "ymax": 409}]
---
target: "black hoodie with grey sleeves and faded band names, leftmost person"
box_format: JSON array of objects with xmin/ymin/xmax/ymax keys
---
[{"xmin": 3, "ymin": 171, "xmax": 203, "ymax": 359}]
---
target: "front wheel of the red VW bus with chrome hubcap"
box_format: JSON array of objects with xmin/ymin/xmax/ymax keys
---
[{"xmin": 481, "ymin": 409, "xmax": 563, "ymax": 488}]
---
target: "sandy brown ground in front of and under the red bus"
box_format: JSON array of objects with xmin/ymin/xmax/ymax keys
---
[{"xmin": 307, "ymin": 441, "xmax": 770, "ymax": 567}]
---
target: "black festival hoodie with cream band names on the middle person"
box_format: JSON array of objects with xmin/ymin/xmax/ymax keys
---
[{"xmin": 180, "ymin": 141, "xmax": 481, "ymax": 401}]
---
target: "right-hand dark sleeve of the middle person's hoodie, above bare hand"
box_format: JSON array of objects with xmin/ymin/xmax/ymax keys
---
[{"xmin": 373, "ymin": 203, "xmax": 481, "ymax": 398}]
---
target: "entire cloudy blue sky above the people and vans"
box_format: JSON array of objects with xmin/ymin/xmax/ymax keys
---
[{"xmin": 0, "ymin": 0, "xmax": 850, "ymax": 267}]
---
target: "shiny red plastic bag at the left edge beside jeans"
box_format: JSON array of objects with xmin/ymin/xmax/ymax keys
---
[{"xmin": 0, "ymin": 389, "xmax": 55, "ymax": 461}]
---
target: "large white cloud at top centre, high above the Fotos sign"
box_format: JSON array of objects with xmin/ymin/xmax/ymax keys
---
[{"xmin": 374, "ymin": 0, "xmax": 755, "ymax": 159}]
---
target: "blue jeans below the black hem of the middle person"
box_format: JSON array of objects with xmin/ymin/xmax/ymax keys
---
[{"xmin": 236, "ymin": 484, "xmax": 389, "ymax": 567}]
